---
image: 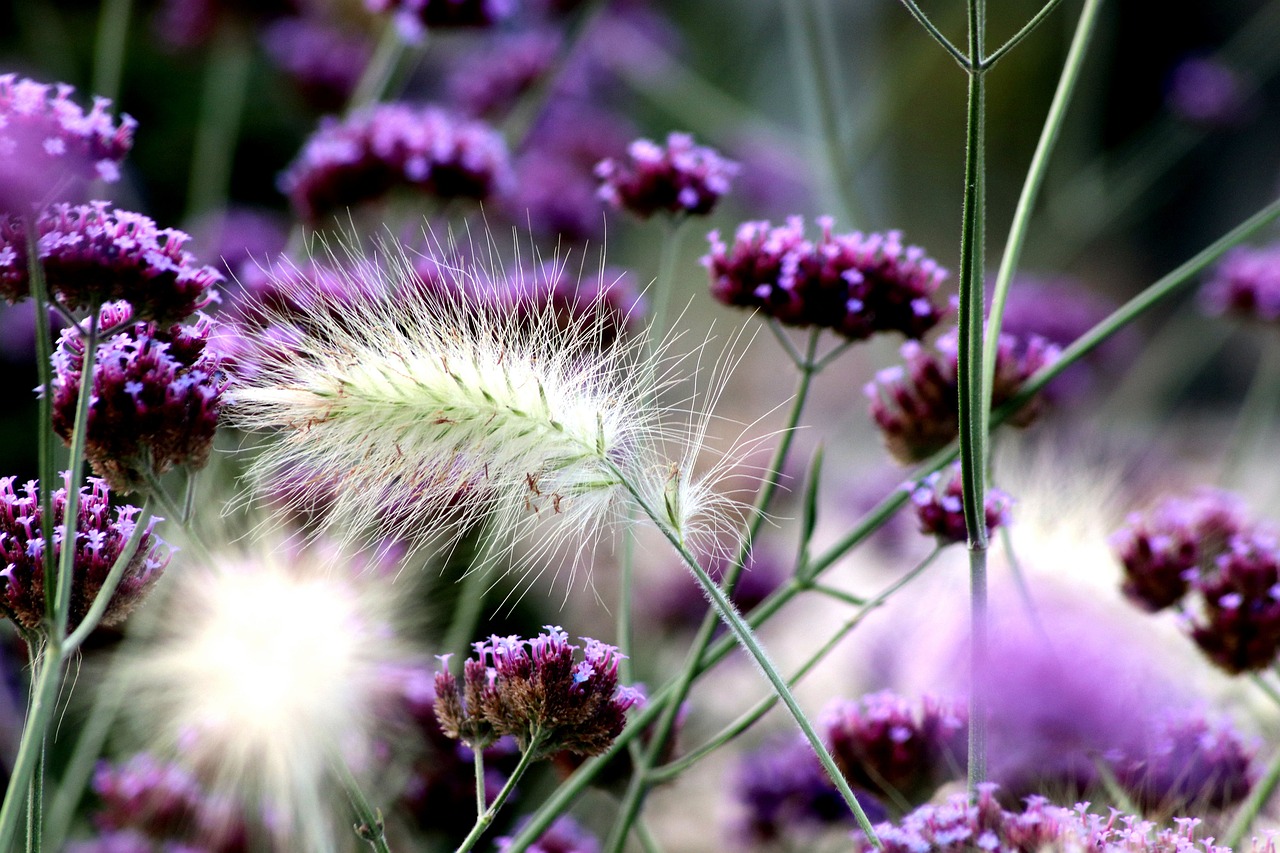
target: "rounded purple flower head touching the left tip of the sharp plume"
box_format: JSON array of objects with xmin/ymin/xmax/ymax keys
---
[{"xmin": 52, "ymin": 302, "xmax": 227, "ymax": 492}]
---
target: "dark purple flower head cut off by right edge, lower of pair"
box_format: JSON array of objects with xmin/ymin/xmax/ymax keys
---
[{"xmin": 1190, "ymin": 532, "xmax": 1280, "ymax": 675}]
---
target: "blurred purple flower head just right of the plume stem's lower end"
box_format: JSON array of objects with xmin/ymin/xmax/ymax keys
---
[{"xmin": 822, "ymin": 690, "xmax": 968, "ymax": 803}]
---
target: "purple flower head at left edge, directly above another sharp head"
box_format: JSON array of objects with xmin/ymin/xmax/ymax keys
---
[{"xmin": 0, "ymin": 201, "xmax": 223, "ymax": 323}]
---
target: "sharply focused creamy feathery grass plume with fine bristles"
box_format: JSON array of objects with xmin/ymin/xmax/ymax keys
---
[{"xmin": 229, "ymin": 230, "xmax": 752, "ymax": 578}]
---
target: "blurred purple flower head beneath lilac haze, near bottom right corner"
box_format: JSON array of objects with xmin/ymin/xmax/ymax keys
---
[{"xmin": 1107, "ymin": 712, "xmax": 1253, "ymax": 815}]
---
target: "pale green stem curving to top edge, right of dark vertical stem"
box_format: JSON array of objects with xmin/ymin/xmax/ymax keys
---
[{"xmin": 982, "ymin": 0, "xmax": 1102, "ymax": 418}]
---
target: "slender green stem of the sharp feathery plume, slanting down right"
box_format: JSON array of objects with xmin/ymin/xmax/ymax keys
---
[{"xmin": 612, "ymin": 466, "xmax": 881, "ymax": 848}]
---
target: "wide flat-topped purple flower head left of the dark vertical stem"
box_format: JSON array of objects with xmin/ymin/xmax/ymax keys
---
[{"xmin": 703, "ymin": 216, "xmax": 947, "ymax": 341}]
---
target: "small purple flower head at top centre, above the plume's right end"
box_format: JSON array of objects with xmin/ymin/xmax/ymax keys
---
[{"xmin": 595, "ymin": 133, "xmax": 739, "ymax": 219}]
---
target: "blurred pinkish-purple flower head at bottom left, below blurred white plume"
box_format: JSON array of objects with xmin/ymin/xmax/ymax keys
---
[{"xmin": 80, "ymin": 752, "xmax": 248, "ymax": 853}]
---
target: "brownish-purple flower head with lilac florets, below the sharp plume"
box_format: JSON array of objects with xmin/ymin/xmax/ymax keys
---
[{"xmin": 435, "ymin": 625, "xmax": 641, "ymax": 757}]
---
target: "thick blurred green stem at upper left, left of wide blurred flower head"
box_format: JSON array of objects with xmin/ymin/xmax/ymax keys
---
[{"xmin": 187, "ymin": 26, "xmax": 253, "ymax": 219}]
